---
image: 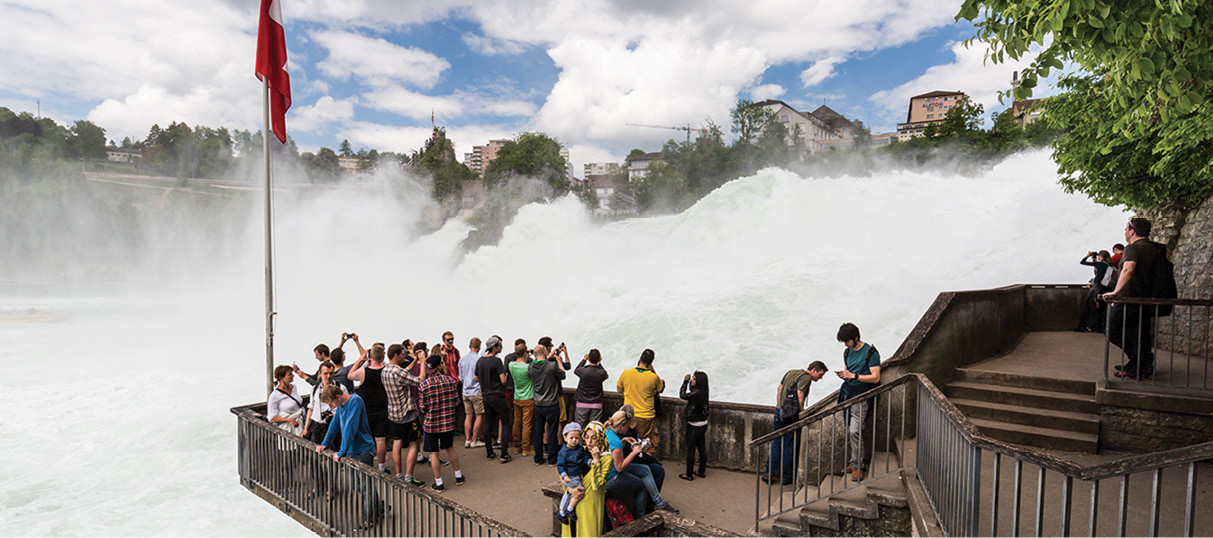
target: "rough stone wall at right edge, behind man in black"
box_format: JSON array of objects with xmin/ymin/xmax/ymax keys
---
[{"xmin": 1141, "ymin": 198, "xmax": 1213, "ymax": 356}]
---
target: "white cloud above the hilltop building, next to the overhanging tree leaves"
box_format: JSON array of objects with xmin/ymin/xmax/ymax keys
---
[{"xmin": 871, "ymin": 42, "xmax": 1048, "ymax": 128}]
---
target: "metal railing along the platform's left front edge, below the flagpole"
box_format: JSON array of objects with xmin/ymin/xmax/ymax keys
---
[{"xmin": 232, "ymin": 405, "xmax": 526, "ymax": 537}]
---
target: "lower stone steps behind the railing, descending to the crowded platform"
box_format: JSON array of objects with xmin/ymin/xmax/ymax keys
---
[{"xmin": 757, "ymin": 452, "xmax": 912, "ymax": 537}]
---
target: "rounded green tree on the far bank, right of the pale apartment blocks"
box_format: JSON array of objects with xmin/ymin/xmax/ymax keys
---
[{"xmin": 484, "ymin": 132, "xmax": 569, "ymax": 193}]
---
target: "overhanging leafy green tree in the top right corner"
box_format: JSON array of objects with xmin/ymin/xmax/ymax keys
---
[{"xmin": 957, "ymin": 0, "xmax": 1213, "ymax": 208}]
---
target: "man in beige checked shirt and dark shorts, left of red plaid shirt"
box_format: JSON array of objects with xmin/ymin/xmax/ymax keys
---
[{"xmin": 382, "ymin": 344, "xmax": 426, "ymax": 486}]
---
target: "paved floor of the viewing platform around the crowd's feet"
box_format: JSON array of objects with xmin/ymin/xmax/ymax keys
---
[{"xmin": 388, "ymin": 437, "xmax": 754, "ymax": 536}]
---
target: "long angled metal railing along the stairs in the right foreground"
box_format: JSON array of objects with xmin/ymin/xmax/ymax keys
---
[{"xmin": 750, "ymin": 373, "xmax": 1213, "ymax": 537}]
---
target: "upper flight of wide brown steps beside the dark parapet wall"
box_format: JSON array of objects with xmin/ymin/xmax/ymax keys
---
[{"xmin": 944, "ymin": 366, "xmax": 1099, "ymax": 453}]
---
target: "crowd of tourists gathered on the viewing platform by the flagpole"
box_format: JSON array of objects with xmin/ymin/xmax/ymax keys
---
[{"xmin": 266, "ymin": 331, "xmax": 708, "ymax": 536}]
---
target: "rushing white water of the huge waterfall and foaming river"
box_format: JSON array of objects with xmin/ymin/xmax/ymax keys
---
[{"xmin": 0, "ymin": 151, "xmax": 1124, "ymax": 536}]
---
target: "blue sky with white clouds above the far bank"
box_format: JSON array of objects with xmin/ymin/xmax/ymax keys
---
[{"xmin": 0, "ymin": 0, "xmax": 1050, "ymax": 177}]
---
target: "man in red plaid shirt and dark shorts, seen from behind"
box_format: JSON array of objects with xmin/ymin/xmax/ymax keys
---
[{"xmin": 417, "ymin": 355, "xmax": 463, "ymax": 492}]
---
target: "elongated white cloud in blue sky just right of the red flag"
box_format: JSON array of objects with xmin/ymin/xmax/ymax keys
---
[{"xmin": 311, "ymin": 30, "xmax": 451, "ymax": 88}]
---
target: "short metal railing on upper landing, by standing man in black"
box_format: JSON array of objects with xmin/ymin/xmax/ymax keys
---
[{"xmin": 1104, "ymin": 297, "xmax": 1213, "ymax": 390}]
